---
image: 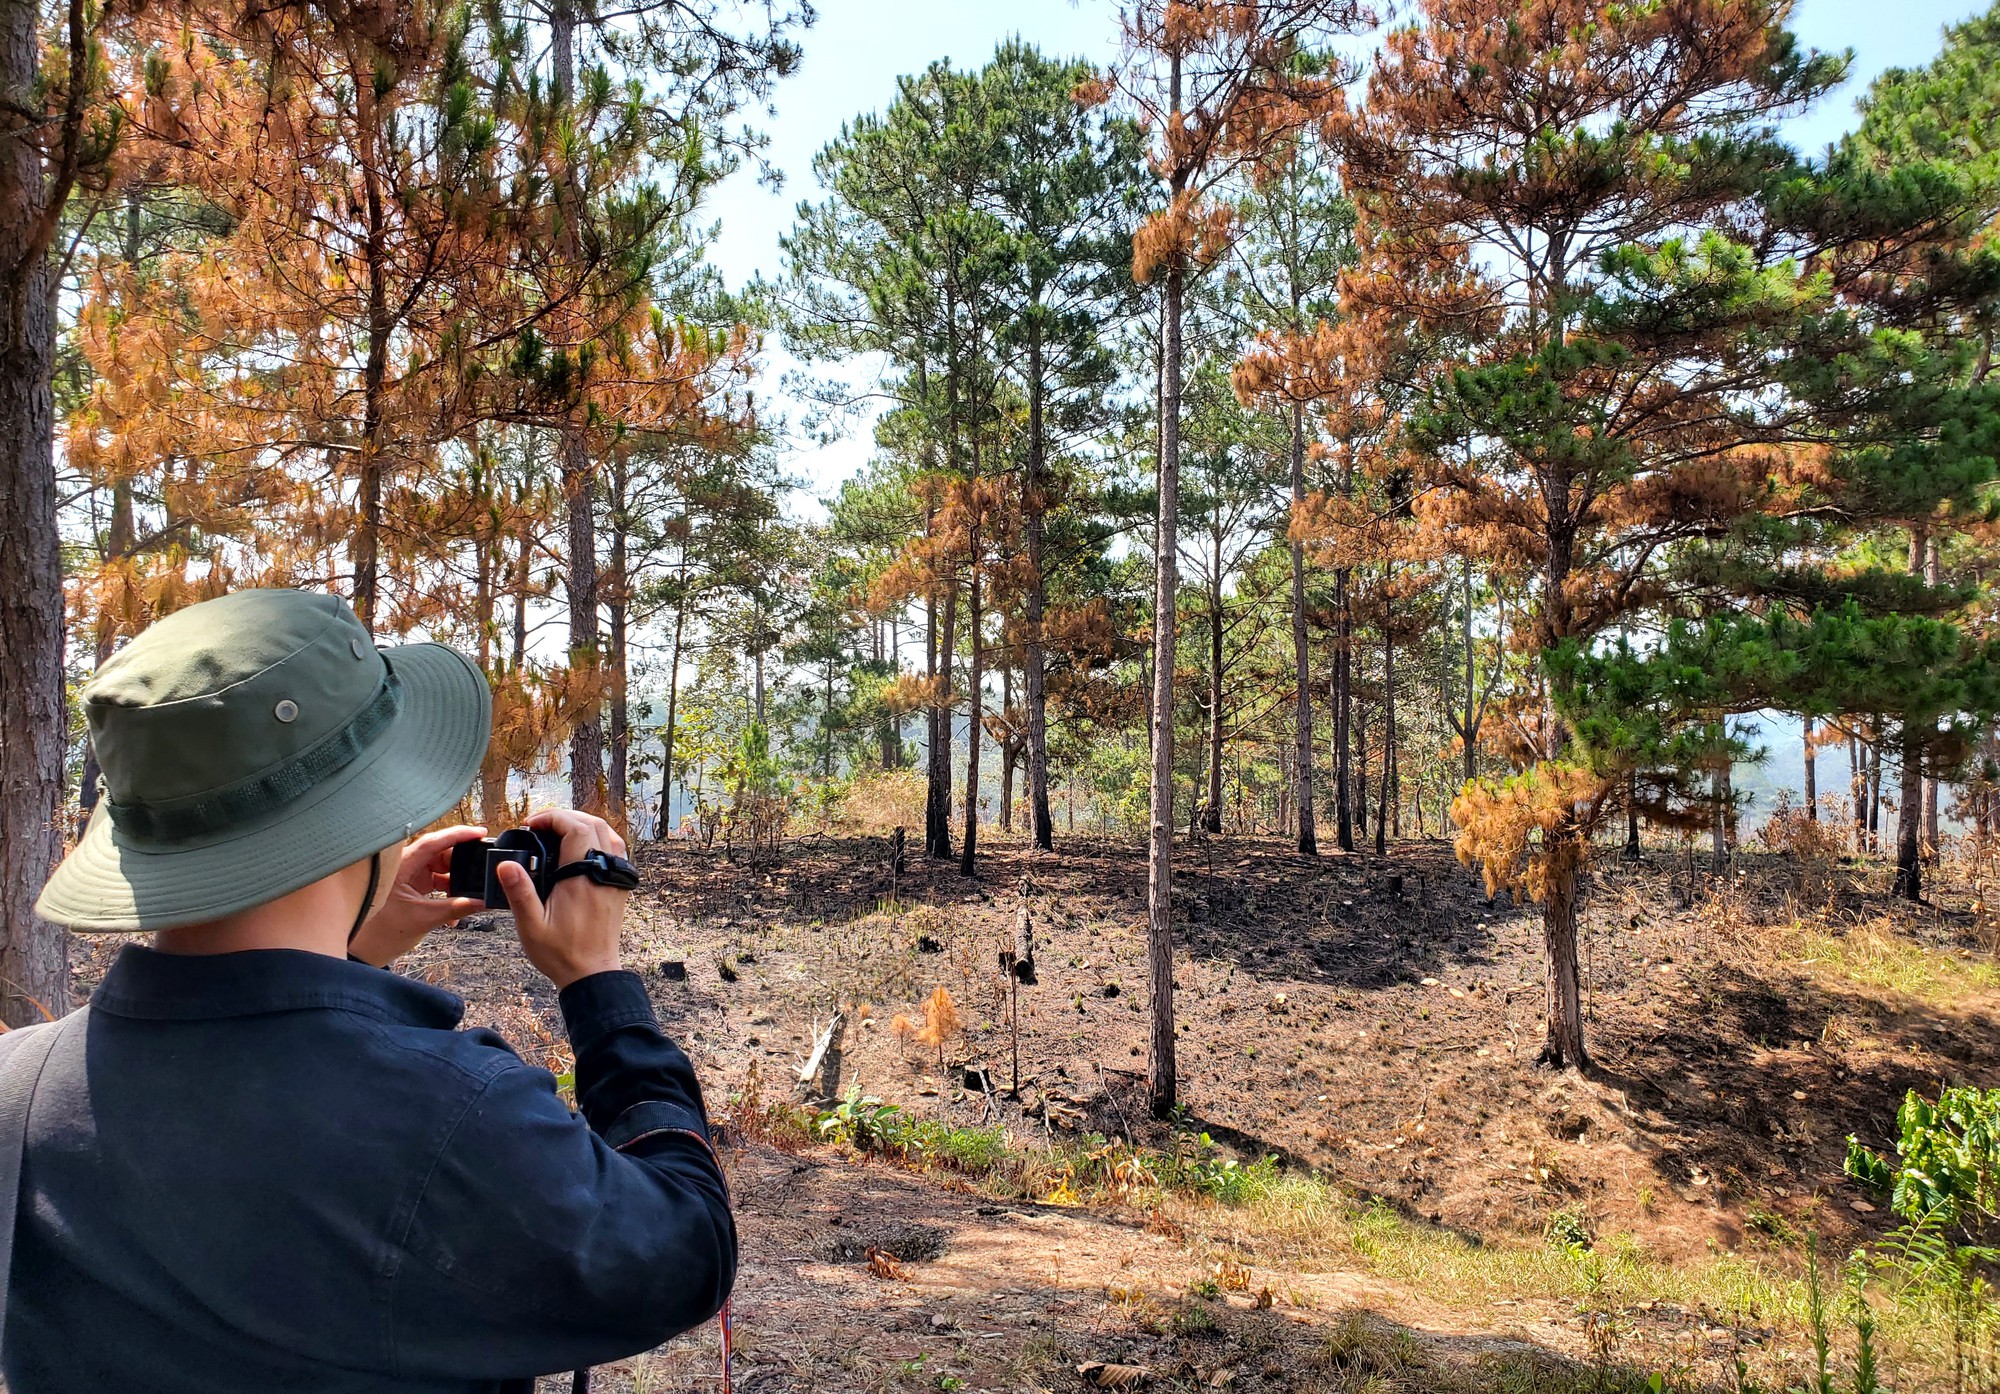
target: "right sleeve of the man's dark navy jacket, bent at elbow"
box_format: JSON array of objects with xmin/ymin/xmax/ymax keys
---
[{"xmin": 390, "ymin": 972, "xmax": 736, "ymax": 1380}]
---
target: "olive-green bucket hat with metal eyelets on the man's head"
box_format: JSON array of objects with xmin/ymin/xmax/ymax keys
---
[{"xmin": 36, "ymin": 590, "xmax": 492, "ymax": 932}]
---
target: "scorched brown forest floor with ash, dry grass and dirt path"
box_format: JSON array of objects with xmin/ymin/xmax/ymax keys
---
[{"xmin": 82, "ymin": 838, "xmax": 2000, "ymax": 1394}]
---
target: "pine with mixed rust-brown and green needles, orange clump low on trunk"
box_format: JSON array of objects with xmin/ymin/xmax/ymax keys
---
[{"xmin": 1340, "ymin": 0, "xmax": 1840, "ymax": 1066}]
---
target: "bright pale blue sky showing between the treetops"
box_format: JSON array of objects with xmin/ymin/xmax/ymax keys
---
[{"xmin": 708, "ymin": 0, "xmax": 1984, "ymax": 514}]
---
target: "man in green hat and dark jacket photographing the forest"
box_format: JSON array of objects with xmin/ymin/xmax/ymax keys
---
[{"xmin": 0, "ymin": 590, "xmax": 736, "ymax": 1394}]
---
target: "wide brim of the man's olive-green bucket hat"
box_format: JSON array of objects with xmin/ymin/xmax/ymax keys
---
[{"xmin": 34, "ymin": 644, "xmax": 492, "ymax": 934}]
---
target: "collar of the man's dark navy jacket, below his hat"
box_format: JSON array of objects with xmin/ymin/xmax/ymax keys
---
[{"xmin": 90, "ymin": 944, "xmax": 466, "ymax": 1030}]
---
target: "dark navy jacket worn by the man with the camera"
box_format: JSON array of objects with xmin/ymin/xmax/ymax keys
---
[{"xmin": 6, "ymin": 948, "xmax": 736, "ymax": 1394}]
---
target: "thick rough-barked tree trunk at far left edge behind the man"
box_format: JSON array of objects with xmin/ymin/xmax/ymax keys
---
[{"xmin": 0, "ymin": 0, "xmax": 70, "ymax": 1026}]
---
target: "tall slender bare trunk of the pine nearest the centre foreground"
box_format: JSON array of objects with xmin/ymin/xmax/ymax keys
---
[{"xmin": 1146, "ymin": 117, "xmax": 1186, "ymax": 1118}]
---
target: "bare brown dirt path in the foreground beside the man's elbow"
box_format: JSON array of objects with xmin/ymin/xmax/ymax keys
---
[{"xmin": 560, "ymin": 1146, "xmax": 1608, "ymax": 1394}]
